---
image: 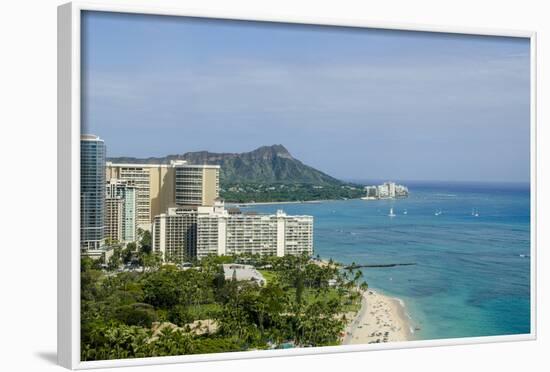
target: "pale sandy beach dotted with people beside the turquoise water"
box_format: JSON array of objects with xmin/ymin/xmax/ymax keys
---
[{"xmin": 342, "ymin": 289, "xmax": 412, "ymax": 345}]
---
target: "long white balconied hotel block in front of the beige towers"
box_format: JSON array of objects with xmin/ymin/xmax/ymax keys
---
[{"xmin": 152, "ymin": 201, "xmax": 313, "ymax": 261}]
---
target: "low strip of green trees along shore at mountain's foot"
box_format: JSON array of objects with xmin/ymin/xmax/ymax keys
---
[{"xmin": 220, "ymin": 183, "xmax": 365, "ymax": 203}]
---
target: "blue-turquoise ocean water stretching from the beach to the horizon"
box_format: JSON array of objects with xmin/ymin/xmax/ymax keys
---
[{"xmin": 239, "ymin": 182, "xmax": 531, "ymax": 340}]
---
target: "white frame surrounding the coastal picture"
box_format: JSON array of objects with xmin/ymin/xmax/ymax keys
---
[{"xmin": 57, "ymin": 1, "xmax": 537, "ymax": 369}]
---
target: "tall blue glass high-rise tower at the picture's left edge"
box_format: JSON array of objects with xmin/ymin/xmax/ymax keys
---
[{"xmin": 80, "ymin": 134, "xmax": 105, "ymax": 250}]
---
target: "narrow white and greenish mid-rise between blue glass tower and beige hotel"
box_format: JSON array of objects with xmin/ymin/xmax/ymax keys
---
[{"xmin": 105, "ymin": 178, "xmax": 137, "ymax": 243}]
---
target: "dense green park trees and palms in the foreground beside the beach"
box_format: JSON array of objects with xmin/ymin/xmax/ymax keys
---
[{"xmin": 81, "ymin": 253, "xmax": 365, "ymax": 360}]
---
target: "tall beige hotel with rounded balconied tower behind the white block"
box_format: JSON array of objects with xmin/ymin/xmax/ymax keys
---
[{"xmin": 106, "ymin": 160, "xmax": 220, "ymax": 230}]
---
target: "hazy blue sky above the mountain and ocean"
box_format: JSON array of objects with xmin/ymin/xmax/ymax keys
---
[{"xmin": 82, "ymin": 12, "xmax": 530, "ymax": 182}]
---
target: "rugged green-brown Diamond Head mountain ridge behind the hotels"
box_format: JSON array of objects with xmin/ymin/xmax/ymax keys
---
[{"xmin": 108, "ymin": 145, "xmax": 364, "ymax": 203}]
